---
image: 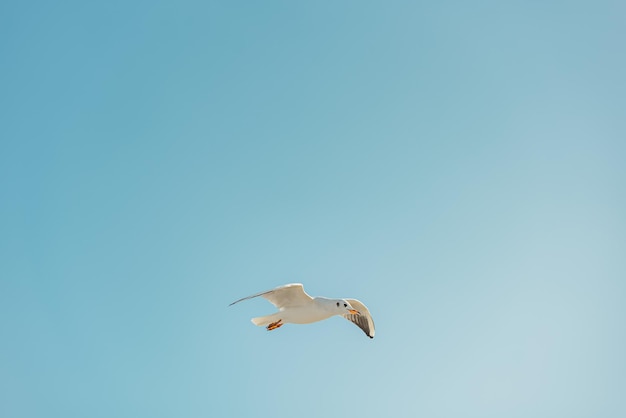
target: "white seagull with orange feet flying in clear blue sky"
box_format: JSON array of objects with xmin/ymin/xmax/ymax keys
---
[{"xmin": 228, "ymin": 283, "xmax": 374, "ymax": 338}]
